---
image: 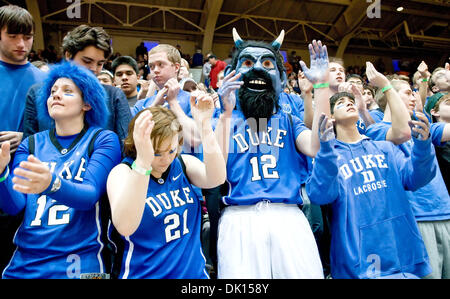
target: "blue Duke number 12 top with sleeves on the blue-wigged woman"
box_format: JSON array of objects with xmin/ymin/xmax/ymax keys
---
[{"xmin": 0, "ymin": 127, "xmax": 121, "ymax": 279}]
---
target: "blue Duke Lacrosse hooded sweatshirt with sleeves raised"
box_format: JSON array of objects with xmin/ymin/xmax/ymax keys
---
[{"xmin": 306, "ymin": 138, "xmax": 433, "ymax": 279}]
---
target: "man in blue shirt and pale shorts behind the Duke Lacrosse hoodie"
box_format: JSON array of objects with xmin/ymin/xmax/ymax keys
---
[{"xmin": 366, "ymin": 69, "xmax": 450, "ymax": 278}]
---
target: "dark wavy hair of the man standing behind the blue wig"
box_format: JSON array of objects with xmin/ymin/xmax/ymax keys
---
[{"xmin": 62, "ymin": 25, "xmax": 113, "ymax": 58}]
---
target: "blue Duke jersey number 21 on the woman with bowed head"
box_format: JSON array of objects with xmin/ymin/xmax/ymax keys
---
[{"xmin": 119, "ymin": 158, "xmax": 209, "ymax": 279}]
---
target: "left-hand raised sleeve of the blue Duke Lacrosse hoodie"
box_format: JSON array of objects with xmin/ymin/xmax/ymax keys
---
[{"xmin": 306, "ymin": 141, "xmax": 339, "ymax": 205}]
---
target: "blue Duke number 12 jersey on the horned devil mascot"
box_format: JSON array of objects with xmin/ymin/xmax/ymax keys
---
[{"xmin": 223, "ymin": 110, "xmax": 308, "ymax": 205}]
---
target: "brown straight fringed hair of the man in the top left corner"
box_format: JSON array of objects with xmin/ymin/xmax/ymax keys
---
[{"xmin": 0, "ymin": 5, "xmax": 34, "ymax": 34}]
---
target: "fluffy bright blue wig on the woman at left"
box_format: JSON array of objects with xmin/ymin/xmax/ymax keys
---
[{"xmin": 36, "ymin": 62, "xmax": 109, "ymax": 128}]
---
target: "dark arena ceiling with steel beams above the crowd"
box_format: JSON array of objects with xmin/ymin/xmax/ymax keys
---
[{"xmin": 5, "ymin": 0, "xmax": 450, "ymax": 62}]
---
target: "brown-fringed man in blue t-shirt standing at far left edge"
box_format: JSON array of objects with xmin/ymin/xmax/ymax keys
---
[{"xmin": 0, "ymin": 5, "xmax": 45, "ymax": 270}]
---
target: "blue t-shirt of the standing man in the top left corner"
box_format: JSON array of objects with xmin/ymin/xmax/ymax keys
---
[{"xmin": 0, "ymin": 61, "xmax": 45, "ymax": 132}]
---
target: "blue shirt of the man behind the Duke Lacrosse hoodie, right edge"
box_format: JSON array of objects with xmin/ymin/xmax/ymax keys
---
[{"xmin": 367, "ymin": 122, "xmax": 450, "ymax": 221}]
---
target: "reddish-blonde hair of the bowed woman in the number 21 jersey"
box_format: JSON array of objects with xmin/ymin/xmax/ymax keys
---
[{"xmin": 124, "ymin": 106, "xmax": 183, "ymax": 159}]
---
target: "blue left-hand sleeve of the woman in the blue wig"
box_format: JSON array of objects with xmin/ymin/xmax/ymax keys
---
[{"xmin": 0, "ymin": 138, "xmax": 29, "ymax": 215}]
